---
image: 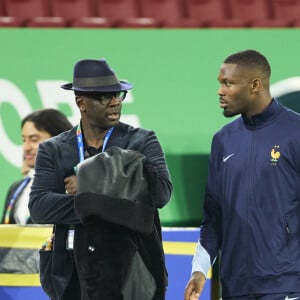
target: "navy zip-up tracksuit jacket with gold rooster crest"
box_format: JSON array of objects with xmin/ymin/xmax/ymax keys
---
[{"xmin": 200, "ymin": 100, "xmax": 300, "ymax": 297}]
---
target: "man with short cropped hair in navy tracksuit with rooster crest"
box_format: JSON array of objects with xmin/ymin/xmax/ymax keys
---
[{"xmin": 185, "ymin": 50, "xmax": 300, "ymax": 300}]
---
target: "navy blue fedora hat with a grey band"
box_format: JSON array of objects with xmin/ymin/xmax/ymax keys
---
[{"xmin": 61, "ymin": 58, "xmax": 132, "ymax": 93}]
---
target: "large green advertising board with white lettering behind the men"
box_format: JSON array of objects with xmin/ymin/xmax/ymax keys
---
[{"xmin": 0, "ymin": 28, "xmax": 300, "ymax": 226}]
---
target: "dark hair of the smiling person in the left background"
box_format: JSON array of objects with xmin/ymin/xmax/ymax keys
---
[{"xmin": 21, "ymin": 108, "xmax": 73, "ymax": 136}]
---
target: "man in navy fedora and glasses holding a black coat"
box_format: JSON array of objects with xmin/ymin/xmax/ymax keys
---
[{"xmin": 29, "ymin": 59, "xmax": 172, "ymax": 300}]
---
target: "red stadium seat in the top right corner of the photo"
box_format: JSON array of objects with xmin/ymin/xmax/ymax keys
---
[{"xmin": 271, "ymin": 0, "xmax": 300, "ymax": 25}]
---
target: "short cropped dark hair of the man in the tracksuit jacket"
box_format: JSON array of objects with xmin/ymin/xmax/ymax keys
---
[{"xmin": 224, "ymin": 49, "xmax": 271, "ymax": 78}]
